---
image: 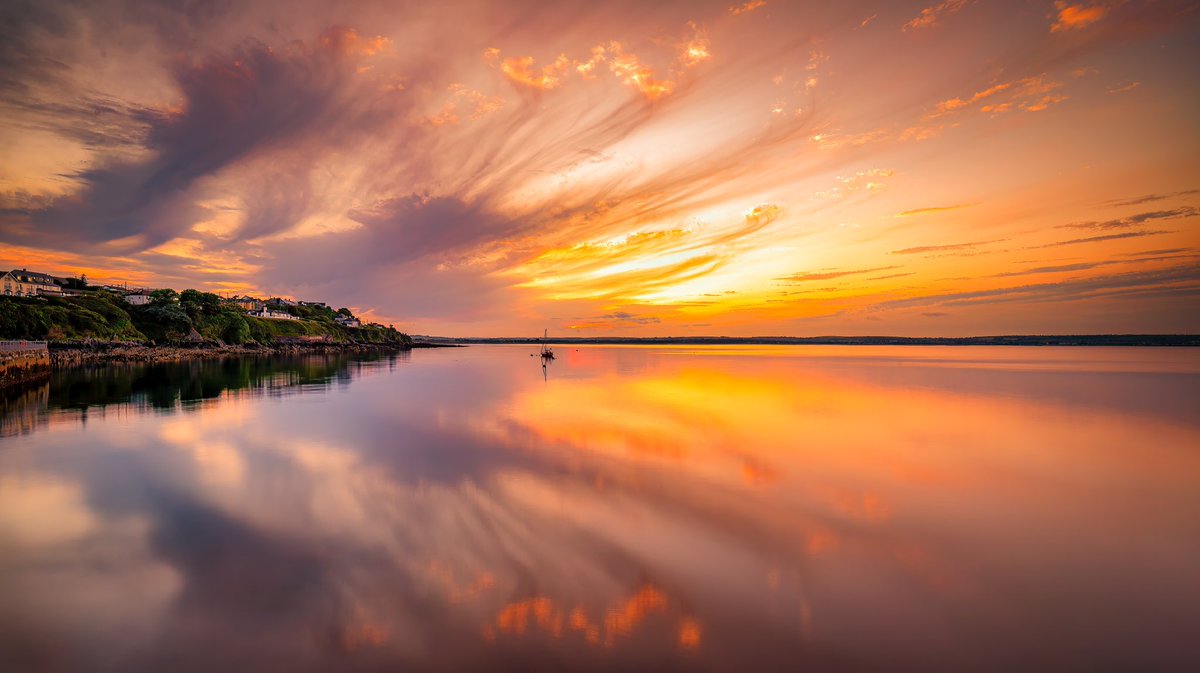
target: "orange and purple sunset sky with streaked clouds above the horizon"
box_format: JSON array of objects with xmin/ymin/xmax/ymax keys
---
[{"xmin": 0, "ymin": 0, "xmax": 1200, "ymax": 336}]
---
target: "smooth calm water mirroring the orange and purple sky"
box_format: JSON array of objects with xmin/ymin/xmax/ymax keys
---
[{"xmin": 0, "ymin": 345, "xmax": 1200, "ymax": 672}]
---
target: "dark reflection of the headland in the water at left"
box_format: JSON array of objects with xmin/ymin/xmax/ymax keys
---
[{"xmin": 0, "ymin": 350, "xmax": 410, "ymax": 437}]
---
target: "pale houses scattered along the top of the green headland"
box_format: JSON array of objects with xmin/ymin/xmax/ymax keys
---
[{"xmin": 0, "ymin": 269, "xmax": 369, "ymax": 328}]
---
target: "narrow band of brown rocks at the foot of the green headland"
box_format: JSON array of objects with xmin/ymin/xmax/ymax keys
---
[{"xmin": 50, "ymin": 342, "xmax": 424, "ymax": 369}]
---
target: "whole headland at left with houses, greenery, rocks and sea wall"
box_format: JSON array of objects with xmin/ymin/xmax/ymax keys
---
[{"xmin": 0, "ymin": 269, "xmax": 413, "ymax": 389}]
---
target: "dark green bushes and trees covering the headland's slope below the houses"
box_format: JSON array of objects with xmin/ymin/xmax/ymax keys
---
[{"xmin": 0, "ymin": 289, "xmax": 412, "ymax": 345}]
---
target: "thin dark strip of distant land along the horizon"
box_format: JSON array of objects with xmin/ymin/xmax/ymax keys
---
[{"xmin": 413, "ymin": 335, "xmax": 1200, "ymax": 348}]
